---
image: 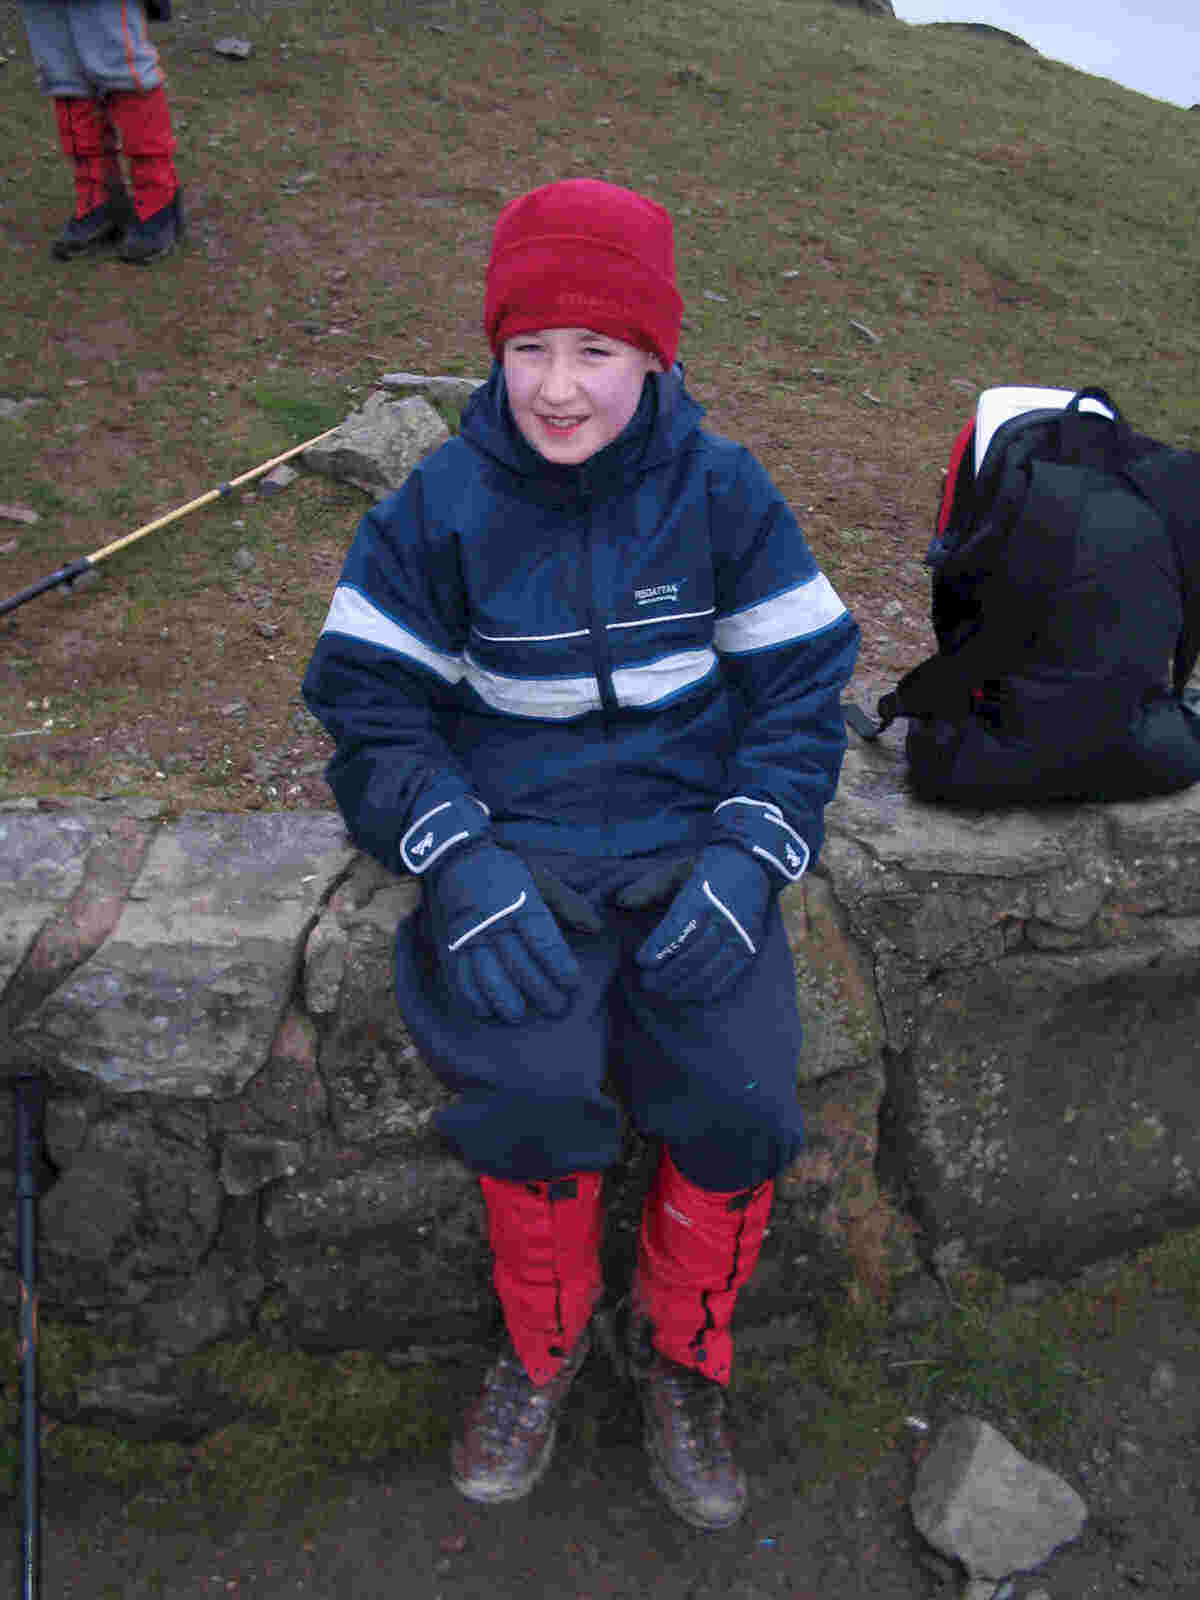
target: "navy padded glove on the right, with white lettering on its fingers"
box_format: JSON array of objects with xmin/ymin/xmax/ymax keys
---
[{"xmin": 616, "ymin": 845, "xmax": 771, "ymax": 1005}]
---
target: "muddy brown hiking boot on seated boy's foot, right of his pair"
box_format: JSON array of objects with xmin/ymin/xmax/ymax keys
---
[{"xmin": 632, "ymin": 1350, "xmax": 747, "ymax": 1530}]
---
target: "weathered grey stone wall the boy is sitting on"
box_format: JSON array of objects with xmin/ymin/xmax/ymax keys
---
[{"xmin": 0, "ymin": 741, "xmax": 1200, "ymax": 1408}]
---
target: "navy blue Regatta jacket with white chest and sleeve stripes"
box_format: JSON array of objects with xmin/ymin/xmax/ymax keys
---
[{"xmin": 304, "ymin": 366, "xmax": 858, "ymax": 878}]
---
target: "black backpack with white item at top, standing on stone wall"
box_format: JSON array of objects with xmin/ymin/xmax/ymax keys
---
[{"xmin": 848, "ymin": 389, "xmax": 1200, "ymax": 806}]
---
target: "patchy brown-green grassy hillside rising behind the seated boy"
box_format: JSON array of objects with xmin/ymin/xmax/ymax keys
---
[{"xmin": 0, "ymin": 0, "xmax": 1200, "ymax": 808}]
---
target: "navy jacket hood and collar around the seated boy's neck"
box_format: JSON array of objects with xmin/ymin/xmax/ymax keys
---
[{"xmin": 459, "ymin": 362, "xmax": 704, "ymax": 493}]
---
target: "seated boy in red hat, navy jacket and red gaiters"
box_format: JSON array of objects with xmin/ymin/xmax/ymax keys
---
[{"xmin": 304, "ymin": 179, "xmax": 858, "ymax": 1528}]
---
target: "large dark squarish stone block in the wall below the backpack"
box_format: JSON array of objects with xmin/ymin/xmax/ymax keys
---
[{"xmin": 894, "ymin": 922, "xmax": 1200, "ymax": 1277}]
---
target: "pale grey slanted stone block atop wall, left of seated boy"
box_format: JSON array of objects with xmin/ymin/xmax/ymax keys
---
[{"xmin": 18, "ymin": 811, "xmax": 354, "ymax": 1098}]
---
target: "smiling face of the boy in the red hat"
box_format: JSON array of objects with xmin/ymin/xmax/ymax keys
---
[{"xmin": 502, "ymin": 328, "xmax": 662, "ymax": 467}]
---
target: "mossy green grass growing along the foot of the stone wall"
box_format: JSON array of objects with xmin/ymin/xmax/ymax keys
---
[{"xmin": 9, "ymin": 1229, "xmax": 1200, "ymax": 1520}]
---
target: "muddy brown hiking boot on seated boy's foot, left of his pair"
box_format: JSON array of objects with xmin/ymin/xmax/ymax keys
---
[{"xmin": 450, "ymin": 1328, "xmax": 590, "ymax": 1506}]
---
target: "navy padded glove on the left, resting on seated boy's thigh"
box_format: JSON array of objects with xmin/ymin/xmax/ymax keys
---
[{"xmin": 426, "ymin": 840, "xmax": 595, "ymax": 1022}]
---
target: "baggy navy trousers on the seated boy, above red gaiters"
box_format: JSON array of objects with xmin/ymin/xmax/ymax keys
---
[{"xmin": 395, "ymin": 854, "xmax": 803, "ymax": 1192}]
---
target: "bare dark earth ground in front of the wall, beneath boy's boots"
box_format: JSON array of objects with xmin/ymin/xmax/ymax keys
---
[{"xmin": 0, "ymin": 1298, "xmax": 1200, "ymax": 1600}]
